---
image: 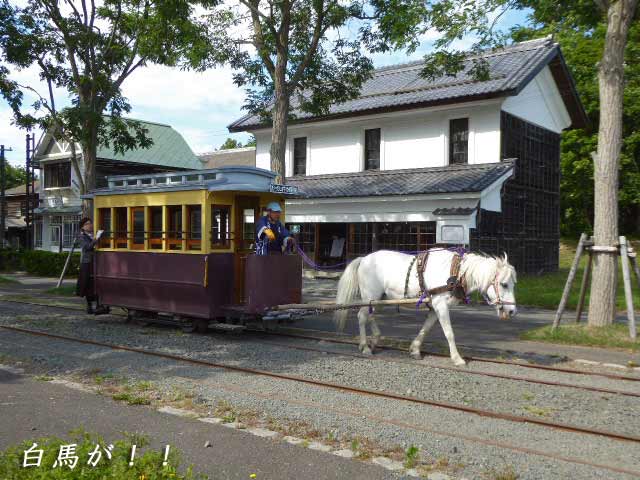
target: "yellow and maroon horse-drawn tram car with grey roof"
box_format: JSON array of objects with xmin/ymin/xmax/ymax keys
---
[{"xmin": 87, "ymin": 167, "xmax": 302, "ymax": 331}]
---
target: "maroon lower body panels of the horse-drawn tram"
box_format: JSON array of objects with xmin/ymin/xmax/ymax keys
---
[{"xmin": 95, "ymin": 251, "xmax": 302, "ymax": 320}]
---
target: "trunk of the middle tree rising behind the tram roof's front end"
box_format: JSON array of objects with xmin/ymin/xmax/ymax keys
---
[{"xmin": 270, "ymin": 58, "xmax": 289, "ymax": 183}]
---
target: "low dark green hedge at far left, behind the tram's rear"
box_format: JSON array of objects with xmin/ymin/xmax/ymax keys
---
[{"xmin": 0, "ymin": 249, "xmax": 80, "ymax": 277}]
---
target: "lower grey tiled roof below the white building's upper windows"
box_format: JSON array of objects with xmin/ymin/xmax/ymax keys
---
[{"xmin": 287, "ymin": 161, "xmax": 513, "ymax": 198}]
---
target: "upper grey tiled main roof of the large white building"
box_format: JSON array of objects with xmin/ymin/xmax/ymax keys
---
[{"xmin": 229, "ymin": 38, "xmax": 586, "ymax": 131}]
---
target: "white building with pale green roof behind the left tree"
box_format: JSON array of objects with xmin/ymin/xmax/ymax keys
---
[{"xmin": 34, "ymin": 121, "xmax": 202, "ymax": 252}]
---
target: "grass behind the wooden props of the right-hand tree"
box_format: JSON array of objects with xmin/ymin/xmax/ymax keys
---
[{"xmin": 516, "ymin": 240, "xmax": 640, "ymax": 310}]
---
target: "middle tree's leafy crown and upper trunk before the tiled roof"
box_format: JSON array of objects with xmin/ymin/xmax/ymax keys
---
[{"xmin": 201, "ymin": 0, "xmax": 442, "ymax": 179}]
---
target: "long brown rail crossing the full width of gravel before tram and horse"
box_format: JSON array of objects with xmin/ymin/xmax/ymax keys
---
[{"xmin": 0, "ymin": 325, "xmax": 640, "ymax": 443}]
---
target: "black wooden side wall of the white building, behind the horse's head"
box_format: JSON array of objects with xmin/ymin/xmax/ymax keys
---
[{"xmin": 471, "ymin": 112, "xmax": 560, "ymax": 274}]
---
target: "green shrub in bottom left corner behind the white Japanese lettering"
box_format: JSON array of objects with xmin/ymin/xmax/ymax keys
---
[{"xmin": 0, "ymin": 431, "xmax": 208, "ymax": 480}]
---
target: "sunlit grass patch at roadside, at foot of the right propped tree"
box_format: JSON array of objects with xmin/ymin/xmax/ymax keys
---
[{"xmin": 520, "ymin": 323, "xmax": 640, "ymax": 351}]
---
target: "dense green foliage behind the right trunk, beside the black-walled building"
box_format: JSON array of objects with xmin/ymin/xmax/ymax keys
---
[{"xmin": 513, "ymin": 24, "xmax": 640, "ymax": 236}]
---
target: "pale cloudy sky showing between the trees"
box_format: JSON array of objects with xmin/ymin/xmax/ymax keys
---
[{"xmin": 0, "ymin": 4, "xmax": 526, "ymax": 165}]
